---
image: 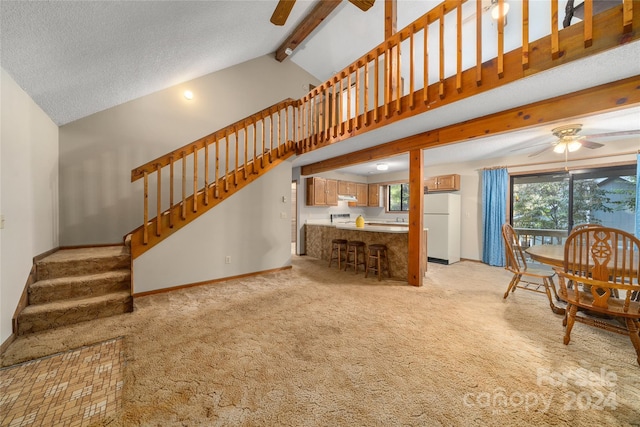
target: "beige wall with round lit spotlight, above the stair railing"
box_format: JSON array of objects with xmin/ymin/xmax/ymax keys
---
[{"xmin": 60, "ymin": 56, "xmax": 320, "ymax": 246}]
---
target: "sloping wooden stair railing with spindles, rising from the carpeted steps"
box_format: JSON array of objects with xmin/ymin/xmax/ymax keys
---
[{"xmin": 131, "ymin": 99, "xmax": 298, "ymax": 258}]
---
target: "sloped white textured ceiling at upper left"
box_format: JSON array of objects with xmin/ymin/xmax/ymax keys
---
[{"xmin": 0, "ymin": 0, "xmax": 313, "ymax": 125}]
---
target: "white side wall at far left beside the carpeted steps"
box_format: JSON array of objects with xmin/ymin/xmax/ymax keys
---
[{"xmin": 0, "ymin": 69, "xmax": 58, "ymax": 343}]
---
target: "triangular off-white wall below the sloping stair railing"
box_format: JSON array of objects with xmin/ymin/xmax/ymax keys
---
[{"xmin": 133, "ymin": 161, "xmax": 291, "ymax": 293}]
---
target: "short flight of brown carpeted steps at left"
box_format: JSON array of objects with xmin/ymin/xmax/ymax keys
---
[{"xmin": 17, "ymin": 245, "xmax": 133, "ymax": 335}]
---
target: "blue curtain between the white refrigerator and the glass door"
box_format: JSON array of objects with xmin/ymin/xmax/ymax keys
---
[{"xmin": 482, "ymin": 168, "xmax": 509, "ymax": 267}]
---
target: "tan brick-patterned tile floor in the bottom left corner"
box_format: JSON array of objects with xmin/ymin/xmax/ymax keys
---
[{"xmin": 0, "ymin": 338, "xmax": 124, "ymax": 427}]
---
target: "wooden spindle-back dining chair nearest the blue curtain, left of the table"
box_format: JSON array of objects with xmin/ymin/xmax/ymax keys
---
[{"xmin": 502, "ymin": 223, "xmax": 565, "ymax": 314}]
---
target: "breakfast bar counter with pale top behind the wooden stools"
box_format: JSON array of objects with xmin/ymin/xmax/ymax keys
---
[{"xmin": 305, "ymin": 224, "xmax": 427, "ymax": 280}]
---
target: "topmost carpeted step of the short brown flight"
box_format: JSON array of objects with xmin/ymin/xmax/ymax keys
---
[{"xmin": 36, "ymin": 245, "xmax": 131, "ymax": 281}]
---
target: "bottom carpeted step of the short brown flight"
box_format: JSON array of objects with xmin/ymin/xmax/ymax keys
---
[{"xmin": 18, "ymin": 290, "xmax": 133, "ymax": 335}]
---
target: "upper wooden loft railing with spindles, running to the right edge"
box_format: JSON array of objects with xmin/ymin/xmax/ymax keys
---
[{"xmin": 298, "ymin": 0, "xmax": 640, "ymax": 154}]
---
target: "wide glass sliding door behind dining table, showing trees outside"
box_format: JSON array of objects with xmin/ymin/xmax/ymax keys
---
[{"xmin": 511, "ymin": 165, "xmax": 636, "ymax": 237}]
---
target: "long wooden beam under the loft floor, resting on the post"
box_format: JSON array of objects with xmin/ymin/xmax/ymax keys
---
[{"xmin": 300, "ymin": 76, "xmax": 640, "ymax": 176}]
